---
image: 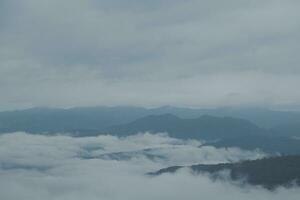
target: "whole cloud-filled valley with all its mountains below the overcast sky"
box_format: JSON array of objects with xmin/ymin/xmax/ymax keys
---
[{"xmin": 0, "ymin": 107, "xmax": 300, "ymax": 200}]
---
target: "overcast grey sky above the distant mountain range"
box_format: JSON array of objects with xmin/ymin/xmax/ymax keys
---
[{"xmin": 0, "ymin": 0, "xmax": 300, "ymax": 110}]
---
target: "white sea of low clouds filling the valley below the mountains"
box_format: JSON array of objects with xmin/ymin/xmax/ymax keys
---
[{"xmin": 0, "ymin": 132, "xmax": 300, "ymax": 200}]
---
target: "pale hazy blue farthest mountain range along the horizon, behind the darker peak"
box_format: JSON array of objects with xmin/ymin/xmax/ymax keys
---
[{"xmin": 0, "ymin": 106, "xmax": 300, "ymax": 136}]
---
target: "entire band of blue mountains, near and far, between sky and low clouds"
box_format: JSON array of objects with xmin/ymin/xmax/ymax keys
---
[{"xmin": 0, "ymin": 107, "xmax": 300, "ymax": 155}]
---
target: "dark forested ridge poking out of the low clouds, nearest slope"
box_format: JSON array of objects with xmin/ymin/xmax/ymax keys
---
[{"xmin": 149, "ymin": 155, "xmax": 300, "ymax": 189}]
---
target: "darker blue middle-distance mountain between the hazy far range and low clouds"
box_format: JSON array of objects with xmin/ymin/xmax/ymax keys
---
[{"xmin": 106, "ymin": 114, "xmax": 300, "ymax": 155}]
